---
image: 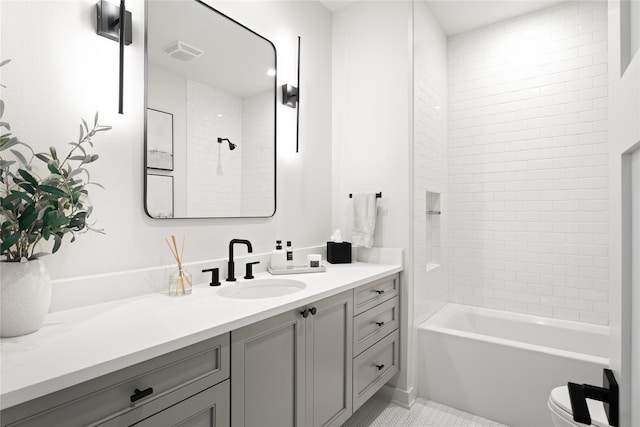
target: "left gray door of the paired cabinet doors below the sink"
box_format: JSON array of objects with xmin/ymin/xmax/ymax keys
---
[{"xmin": 231, "ymin": 310, "xmax": 305, "ymax": 427}]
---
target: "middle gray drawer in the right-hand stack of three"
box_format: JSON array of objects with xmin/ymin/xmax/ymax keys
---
[{"xmin": 353, "ymin": 297, "xmax": 399, "ymax": 355}]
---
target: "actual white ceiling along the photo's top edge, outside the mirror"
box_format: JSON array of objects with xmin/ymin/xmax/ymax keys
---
[{"xmin": 321, "ymin": 0, "xmax": 564, "ymax": 36}]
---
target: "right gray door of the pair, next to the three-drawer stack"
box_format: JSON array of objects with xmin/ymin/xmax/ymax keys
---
[{"xmin": 305, "ymin": 291, "xmax": 353, "ymax": 427}]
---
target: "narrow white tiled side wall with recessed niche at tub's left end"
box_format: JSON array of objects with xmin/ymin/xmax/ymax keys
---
[{"xmin": 413, "ymin": 1, "xmax": 449, "ymax": 324}]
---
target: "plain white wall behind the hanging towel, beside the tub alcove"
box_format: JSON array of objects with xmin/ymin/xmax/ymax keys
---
[{"xmin": 330, "ymin": 1, "xmax": 415, "ymax": 406}]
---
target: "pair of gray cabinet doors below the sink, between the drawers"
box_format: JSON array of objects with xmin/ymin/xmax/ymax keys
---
[{"xmin": 231, "ymin": 291, "xmax": 353, "ymax": 427}]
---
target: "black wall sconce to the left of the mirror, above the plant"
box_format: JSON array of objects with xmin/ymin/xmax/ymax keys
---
[{"xmin": 97, "ymin": 0, "xmax": 132, "ymax": 114}]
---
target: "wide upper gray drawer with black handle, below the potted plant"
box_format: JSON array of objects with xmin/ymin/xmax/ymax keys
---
[{"xmin": 2, "ymin": 334, "xmax": 230, "ymax": 427}]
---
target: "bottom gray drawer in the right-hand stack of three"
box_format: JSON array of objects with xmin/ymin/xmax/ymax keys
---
[{"xmin": 353, "ymin": 330, "xmax": 400, "ymax": 412}]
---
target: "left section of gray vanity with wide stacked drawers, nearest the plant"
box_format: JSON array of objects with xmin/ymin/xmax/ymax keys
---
[{"xmin": 1, "ymin": 334, "xmax": 231, "ymax": 427}]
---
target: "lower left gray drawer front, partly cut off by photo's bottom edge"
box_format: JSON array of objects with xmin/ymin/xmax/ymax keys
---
[{"xmin": 134, "ymin": 380, "xmax": 231, "ymax": 427}]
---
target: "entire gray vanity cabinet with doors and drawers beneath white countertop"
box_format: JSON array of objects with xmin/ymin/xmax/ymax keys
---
[{"xmin": 0, "ymin": 274, "xmax": 400, "ymax": 427}]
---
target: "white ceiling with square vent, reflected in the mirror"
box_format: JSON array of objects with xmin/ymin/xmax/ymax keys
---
[{"xmin": 149, "ymin": 0, "xmax": 275, "ymax": 98}]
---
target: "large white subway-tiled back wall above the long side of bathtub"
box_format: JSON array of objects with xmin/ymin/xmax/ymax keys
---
[{"xmin": 448, "ymin": 1, "xmax": 609, "ymax": 324}]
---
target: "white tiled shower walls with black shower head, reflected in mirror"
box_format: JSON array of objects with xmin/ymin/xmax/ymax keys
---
[{"xmin": 186, "ymin": 80, "xmax": 275, "ymax": 217}]
